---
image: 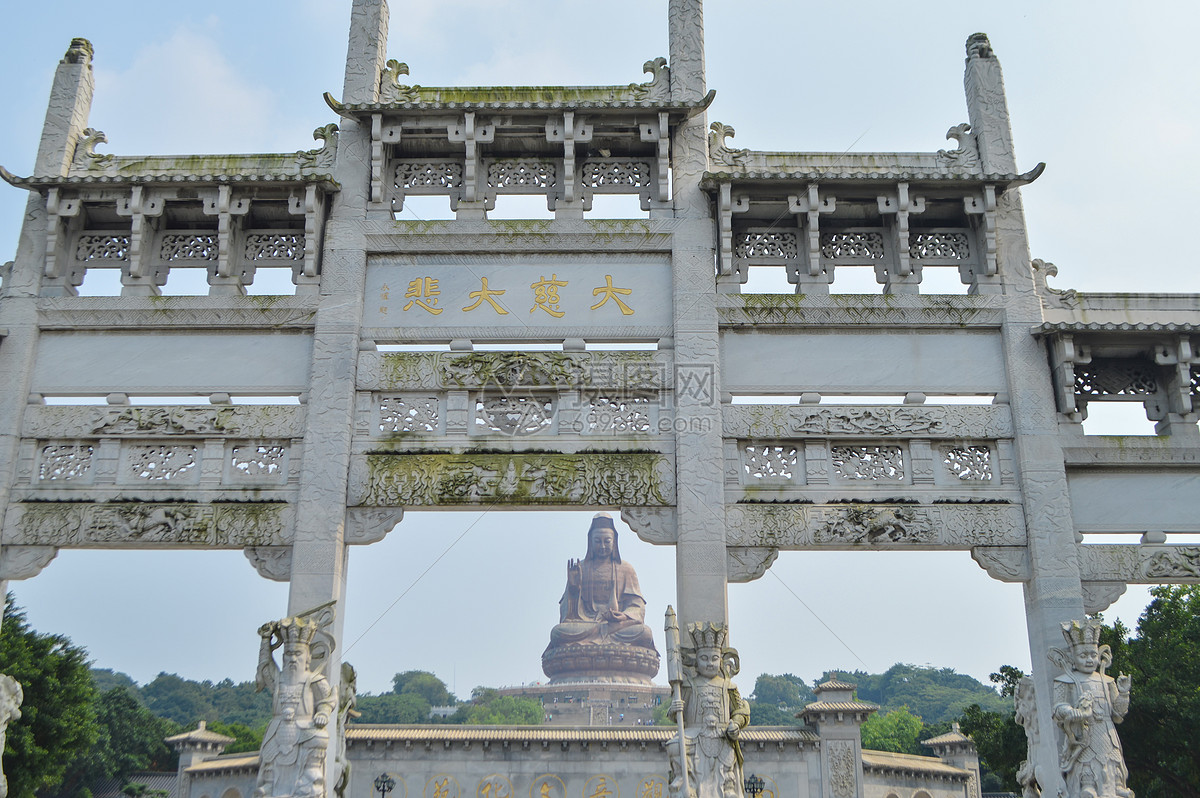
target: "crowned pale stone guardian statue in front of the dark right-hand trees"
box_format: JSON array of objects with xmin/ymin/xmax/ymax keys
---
[{"xmin": 1050, "ymin": 618, "xmax": 1133, "ymax": 798}]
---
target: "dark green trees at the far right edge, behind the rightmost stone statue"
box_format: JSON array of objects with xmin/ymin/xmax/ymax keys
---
[{"xmin": 1103, "ymin": 584, "xmax": 1200, "ymax": 798}]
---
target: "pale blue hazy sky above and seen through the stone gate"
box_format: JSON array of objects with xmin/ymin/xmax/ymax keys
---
[{"xmin": 0, "ymin": 0, "xmax": 1200, "ymax": 694}]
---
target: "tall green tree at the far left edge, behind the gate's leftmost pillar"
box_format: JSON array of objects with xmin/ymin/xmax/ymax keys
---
[{"xmin": 0, "ymin": 594, "xmax": 100, "ymax": 798}]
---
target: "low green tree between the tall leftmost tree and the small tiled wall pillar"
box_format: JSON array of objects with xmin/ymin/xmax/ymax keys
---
[{"xmin": 62, "ymin": 688, "xmax": 179, "ymax": 792}]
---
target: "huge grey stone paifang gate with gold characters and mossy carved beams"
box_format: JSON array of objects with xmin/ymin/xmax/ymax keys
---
[{"xmin": 0, "ymin": 0, "xmax": 1200, "ymax": 798}]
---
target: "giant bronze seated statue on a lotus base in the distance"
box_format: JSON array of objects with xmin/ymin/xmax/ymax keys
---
[{"xmin": 541, "ymin": 512, "xmax": 659, "ymax": 684}]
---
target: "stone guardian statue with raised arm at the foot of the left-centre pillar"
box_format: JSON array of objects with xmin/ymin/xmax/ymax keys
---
[{"xmin": 254, "ymin": 605, "xmax": 337, "ymax": 798}]
